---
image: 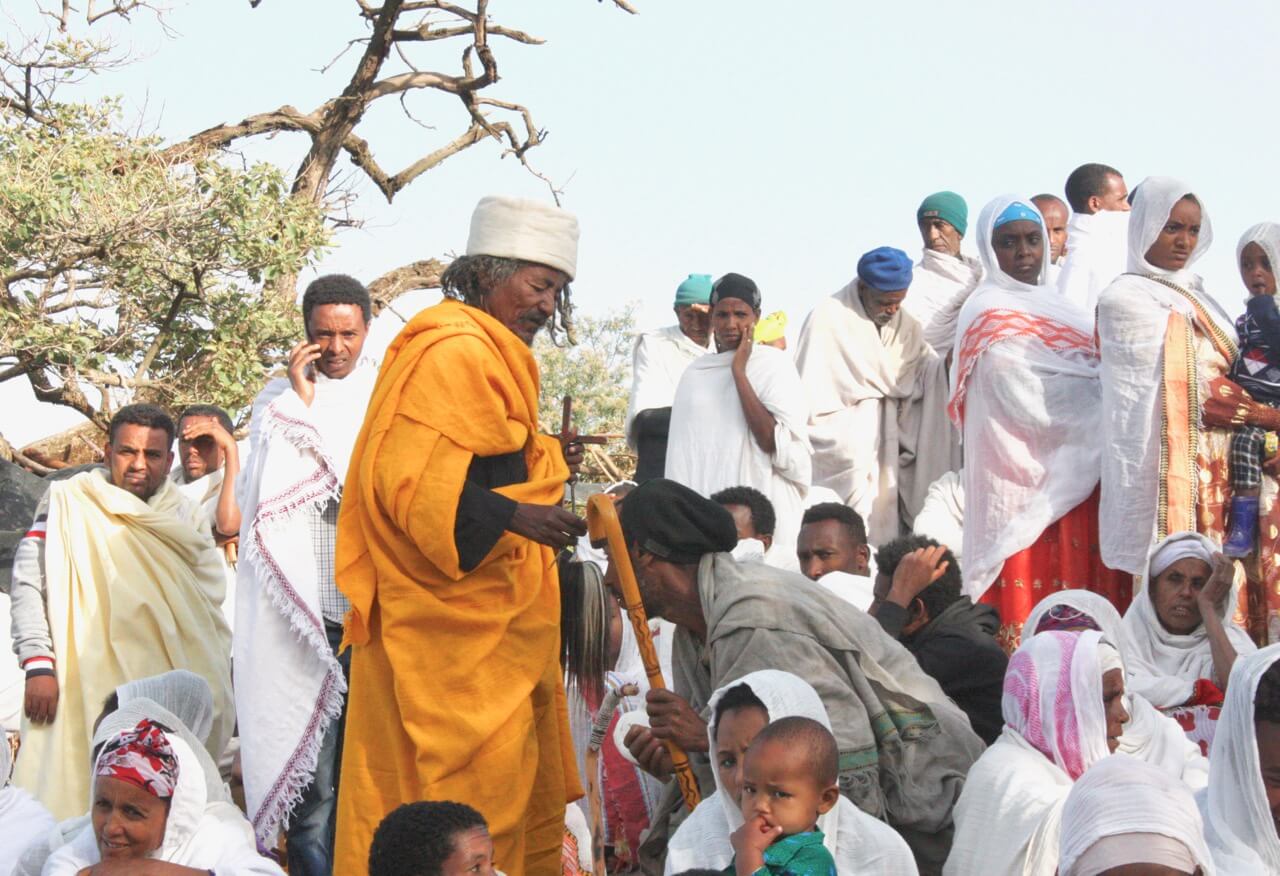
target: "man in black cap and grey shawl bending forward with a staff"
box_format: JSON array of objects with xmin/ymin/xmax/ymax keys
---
[{"xmin": 621, "ymin": 479, "xmax": 983, "ymax": 872}]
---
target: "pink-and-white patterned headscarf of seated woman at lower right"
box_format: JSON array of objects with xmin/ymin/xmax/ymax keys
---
[{"xmin": 1001, "ymin": 630, "xmax": 1108, "ymax": 780}]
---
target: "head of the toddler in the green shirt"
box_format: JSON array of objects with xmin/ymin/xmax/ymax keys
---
[{"xmin": 740, "ymin": 739, "xmax": 840, "ymax": 836}]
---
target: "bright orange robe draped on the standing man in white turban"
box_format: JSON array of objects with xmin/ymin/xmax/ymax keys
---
[{"xmin": 334, "ymin": 301, "xmax": 581, "ymax": 876}]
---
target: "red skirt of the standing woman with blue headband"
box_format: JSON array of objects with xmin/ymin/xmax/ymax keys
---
[{"xmin": 980, "ymin": 489, "xmax": 1133, "ymax": 653}]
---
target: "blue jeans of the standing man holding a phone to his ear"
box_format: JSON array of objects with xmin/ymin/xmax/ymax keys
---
[{"xmin": 284, "ymin": 621, "xmax": 351, "ymax": 876}]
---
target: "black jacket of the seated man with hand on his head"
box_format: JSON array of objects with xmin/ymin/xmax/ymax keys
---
[{"xmin": 876, "ymin": 596, "xmax": 1009, "ymax": 745}]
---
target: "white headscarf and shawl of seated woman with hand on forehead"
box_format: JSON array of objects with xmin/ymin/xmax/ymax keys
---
[{"xmin": 1124, "ymin": 533, "xmax": 1257, "ymax": 708}]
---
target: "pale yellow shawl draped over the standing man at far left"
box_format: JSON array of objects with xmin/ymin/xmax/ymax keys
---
[{"xmin": 14, "ymin": 469, "xmax": 234, "ymax": 820}]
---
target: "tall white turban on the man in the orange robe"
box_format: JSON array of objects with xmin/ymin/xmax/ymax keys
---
[{"xmin": 467, "ymin": 195, "xmax": 577, "ymax": 279}]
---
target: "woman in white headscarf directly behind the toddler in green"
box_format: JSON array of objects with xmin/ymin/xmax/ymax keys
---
[{"xmin": 666, "ymin": 670, "xmax": 916, "ymax": 876}]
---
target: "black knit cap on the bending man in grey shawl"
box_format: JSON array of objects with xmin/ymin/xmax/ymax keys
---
[{"xmin": 621, "ymin": 478, "xmax": 737, "ymax": 562}]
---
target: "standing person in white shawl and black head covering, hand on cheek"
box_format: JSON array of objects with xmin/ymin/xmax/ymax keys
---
[{"xmin": 666, "ymin": 274, "xmax": 812, "ymax": 557}]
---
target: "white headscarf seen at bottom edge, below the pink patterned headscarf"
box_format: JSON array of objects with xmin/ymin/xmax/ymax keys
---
[{"xmin": 1057, "ymin": 754, "xmax": 1213, "ymax": 876}]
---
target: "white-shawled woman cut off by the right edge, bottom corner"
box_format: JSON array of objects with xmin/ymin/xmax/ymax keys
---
[{"xmin": 1198, "ymin": 645, "xmax": 1280, "ymax": 876}]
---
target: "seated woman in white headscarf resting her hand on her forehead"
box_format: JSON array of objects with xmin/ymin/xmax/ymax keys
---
[{"xmin": 1124, "ymin": 533, "xmax": 1257, "ymax": 756}]
